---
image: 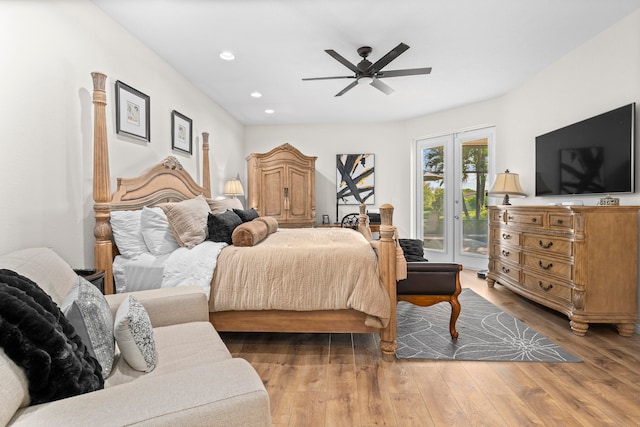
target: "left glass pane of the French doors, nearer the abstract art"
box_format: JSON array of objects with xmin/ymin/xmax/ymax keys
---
[{"xmin": 422, "ymin": 145, "xmax": 445, "ymax": 250}]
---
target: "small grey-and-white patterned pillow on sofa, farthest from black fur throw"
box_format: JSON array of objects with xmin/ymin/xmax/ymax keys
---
[{"xmin": 114, "ymin": 295, "xmax": 158, "ymax": 372}]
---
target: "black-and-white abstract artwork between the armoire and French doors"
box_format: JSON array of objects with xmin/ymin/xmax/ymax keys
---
[{"xmin": 336, "ymin": 154, "xmax": 375, "ymax": 205}]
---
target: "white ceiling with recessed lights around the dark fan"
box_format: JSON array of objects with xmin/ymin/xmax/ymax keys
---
[{"xmin": 93, "ymin": 0, "xmax": 640, "ymax": 125}]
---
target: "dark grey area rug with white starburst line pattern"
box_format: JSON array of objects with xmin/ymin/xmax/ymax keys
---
[{"xmin": 396, "ymin": 288, "xmax": 581, "ymax": 362}]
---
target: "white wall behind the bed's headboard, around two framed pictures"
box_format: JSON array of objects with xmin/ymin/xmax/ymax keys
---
[{"xmin": 0, "ymin": 0, "xmax": 245, "ymax": 267}]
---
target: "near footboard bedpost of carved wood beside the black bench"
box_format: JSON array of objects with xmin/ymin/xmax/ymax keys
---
[{"xmin": 378, "ymin": 204, "xmax": 397, "ymax": 361}]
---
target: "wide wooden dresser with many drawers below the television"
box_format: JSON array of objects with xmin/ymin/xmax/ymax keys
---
[{"xmin": 487, "ymin": 206, "xmax": 640, "ymax": 336}]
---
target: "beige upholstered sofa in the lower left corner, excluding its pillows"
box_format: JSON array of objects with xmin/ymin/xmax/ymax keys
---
[{"xmin": 0, "ymin": 248, "xmax": 271, "ymax": 426}]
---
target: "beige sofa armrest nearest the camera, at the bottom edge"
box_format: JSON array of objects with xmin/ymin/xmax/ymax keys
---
[{"xmin": 11, "ymin": 358, "xmax": 271, "ymax": 427}]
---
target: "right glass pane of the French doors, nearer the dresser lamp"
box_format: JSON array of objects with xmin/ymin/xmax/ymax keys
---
[{"xmin": 460, "ymin": 139, "xmax": 489, "ymax": 255}]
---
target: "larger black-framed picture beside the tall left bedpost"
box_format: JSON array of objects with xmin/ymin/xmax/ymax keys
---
[{"xmin": 116, "ymin": 80, "xmax": 151, "ymax": 141}]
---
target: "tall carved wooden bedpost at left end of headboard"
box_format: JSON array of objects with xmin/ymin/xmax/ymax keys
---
[{"xmin": 91, "ymin": 72, "xmax": 114, "ymax": 294}]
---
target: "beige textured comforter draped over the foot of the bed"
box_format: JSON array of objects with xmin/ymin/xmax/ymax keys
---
[{"xmin": 209, "ymin": 228, "xmax": 390, "ymax": 327}]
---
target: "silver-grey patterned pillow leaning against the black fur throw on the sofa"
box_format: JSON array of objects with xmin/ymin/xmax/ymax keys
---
[{"xmin": 60, "ymin": 276, "xmax": 115, "ymax": 378}]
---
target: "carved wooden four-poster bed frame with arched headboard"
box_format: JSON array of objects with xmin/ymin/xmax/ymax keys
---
[{"xmin": 91, "ymin": 72, "xmax": 396, "ymax": 360}]
